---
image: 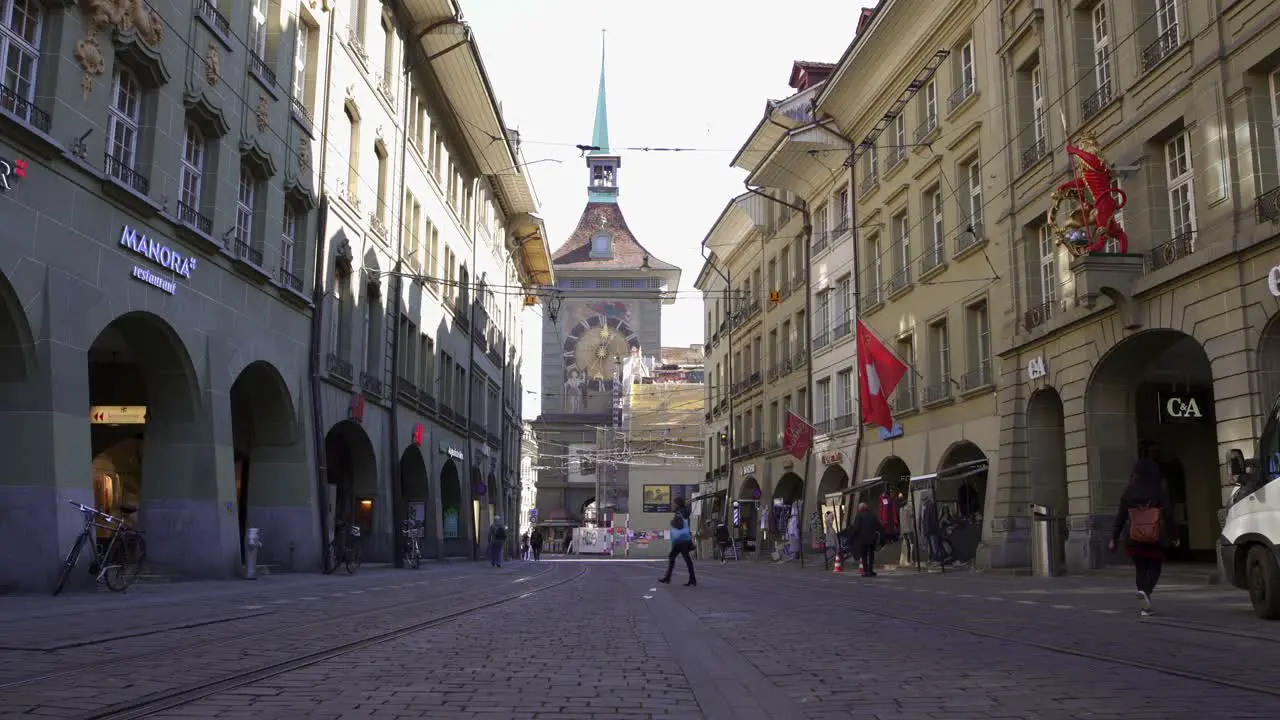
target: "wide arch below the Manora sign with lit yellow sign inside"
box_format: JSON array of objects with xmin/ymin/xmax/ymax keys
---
[{"xmin": 86, "ymin": 311, "xmax": 213, "ymax": 575}]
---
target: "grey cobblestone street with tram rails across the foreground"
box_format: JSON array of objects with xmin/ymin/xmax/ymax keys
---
[{"xmin": 0, "ymin": 560, "xmax": 1280, "ymax": 720}]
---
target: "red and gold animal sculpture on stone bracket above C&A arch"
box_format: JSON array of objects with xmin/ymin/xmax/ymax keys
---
[{"xmin": 1047, "ymin": 133, "xmax": 1129, "ymax": 258}]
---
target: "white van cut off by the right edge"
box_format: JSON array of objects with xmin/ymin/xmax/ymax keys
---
[{"xmin": 1219, "ymin": 398, "xmax": 1280, "ymax": 620}]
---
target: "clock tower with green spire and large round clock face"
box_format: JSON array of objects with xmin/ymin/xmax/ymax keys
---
[{"xmin": 535, "ymin": 35, "xmax": 680, "ymax": 527}]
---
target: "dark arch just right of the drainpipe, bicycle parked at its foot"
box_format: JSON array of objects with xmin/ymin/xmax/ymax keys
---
[{"xmin": 324, "ymin": 420, "xmax": 376, "ymax": 562}]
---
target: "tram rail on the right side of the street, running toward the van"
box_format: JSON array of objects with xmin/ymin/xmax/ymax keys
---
[{"xmin": 672, "ymin": 561, "xmax": 1280, "ymax": 697}]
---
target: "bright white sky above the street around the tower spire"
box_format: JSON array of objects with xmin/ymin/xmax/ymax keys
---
[{"xmin": 461, "ymin": 0, "xmax": 874, "ymax": 418}]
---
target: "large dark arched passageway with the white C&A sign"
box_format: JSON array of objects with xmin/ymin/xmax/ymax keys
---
[{"xmin": 1090, "ymin": 329, "xmax": 1222, "ymax": 562}]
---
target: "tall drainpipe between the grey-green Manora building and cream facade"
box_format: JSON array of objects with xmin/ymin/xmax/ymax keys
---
[{"xmin": 307, "ymin": 1, "xmax": 334, "ymax": 574}]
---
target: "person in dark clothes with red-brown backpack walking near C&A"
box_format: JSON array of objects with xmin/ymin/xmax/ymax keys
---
[{"xmin": 1107, "ymin": 457, "xmax": 1178, "ymax": 618}]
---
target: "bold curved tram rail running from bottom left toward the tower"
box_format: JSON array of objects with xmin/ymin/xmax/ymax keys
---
[{"xmin": 72, "ymin": 568, "xmax": 589, "ymax": 720}]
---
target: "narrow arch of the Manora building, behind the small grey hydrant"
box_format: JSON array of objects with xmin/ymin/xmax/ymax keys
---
[{"xmin": 230, "ymin": 361, "xmax": 305, "ymax": 570}]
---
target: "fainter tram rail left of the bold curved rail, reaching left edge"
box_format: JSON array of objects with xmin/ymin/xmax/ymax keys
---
[{"xmin": 0, "ymin": 568, "xmax": 554, "ymax": 702}]
